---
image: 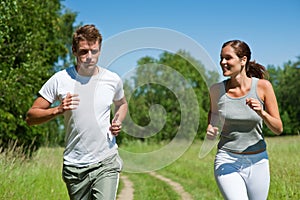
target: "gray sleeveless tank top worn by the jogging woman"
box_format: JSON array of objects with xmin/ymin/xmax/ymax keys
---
[{"xmin": 218, "ymin": 78, "xmax": 266, "ymax": 153}]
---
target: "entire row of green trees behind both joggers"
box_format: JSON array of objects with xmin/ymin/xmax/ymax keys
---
[{"xmin": 0, "ymin": 0, "xmax": 300, "ymax": 151}]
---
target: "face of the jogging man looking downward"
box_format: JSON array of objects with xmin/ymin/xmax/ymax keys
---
[{"xmin": 75, "ymin": 40, "xmax": 100, "ymax": 74}]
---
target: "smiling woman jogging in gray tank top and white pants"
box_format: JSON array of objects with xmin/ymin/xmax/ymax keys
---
[{"xmin": 207, "ymin": 40, "xmax": 283, "ymax": 200}]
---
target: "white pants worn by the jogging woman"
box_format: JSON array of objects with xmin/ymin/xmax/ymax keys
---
[{"xmin": 215, "ymin": 150, "xmax": 270, "ymax": 200}]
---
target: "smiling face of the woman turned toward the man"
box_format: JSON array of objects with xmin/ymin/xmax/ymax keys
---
[{"xmin": 220, "ymin": 45, "xmax": 247, "ymax": 76}]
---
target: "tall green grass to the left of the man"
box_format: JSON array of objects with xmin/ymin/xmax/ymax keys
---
[{"xmin": 0, "ymin": 145, "xmax": 68, "ymax": 200}]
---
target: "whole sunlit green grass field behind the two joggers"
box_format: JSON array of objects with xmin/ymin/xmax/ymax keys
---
[{"xmin": 0, "ymin": 136, "xmax": 300, "ymax": 200}]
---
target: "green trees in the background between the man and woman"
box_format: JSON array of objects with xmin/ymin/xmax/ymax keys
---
[{"xmin": 118, "ymin": 51, "xmax": 213, "ymax": 142}]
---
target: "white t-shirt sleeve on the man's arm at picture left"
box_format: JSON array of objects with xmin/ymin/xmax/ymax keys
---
[{"xmin": 39, "ymin": 75, "xmax": 58, "ymax": 103}]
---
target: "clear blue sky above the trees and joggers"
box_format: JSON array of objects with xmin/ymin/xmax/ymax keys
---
[{"xmin": 62, "ymin": 0, "xmax": 300, "ymax": 75}]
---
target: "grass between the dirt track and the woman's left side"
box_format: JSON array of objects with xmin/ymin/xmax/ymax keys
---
[{"xmin": 157, "ymin": 142, "xmax": 223, "ymax": 200}]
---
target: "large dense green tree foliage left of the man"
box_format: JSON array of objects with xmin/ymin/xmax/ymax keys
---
[{"xmin": 0, "ymin": 0, "xmax": 76, "ymax": 153}]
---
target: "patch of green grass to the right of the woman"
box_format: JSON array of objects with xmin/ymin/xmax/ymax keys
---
[{"xmin": 267, "ymin": 136, "xmax": 300, "ymax": 200}]
